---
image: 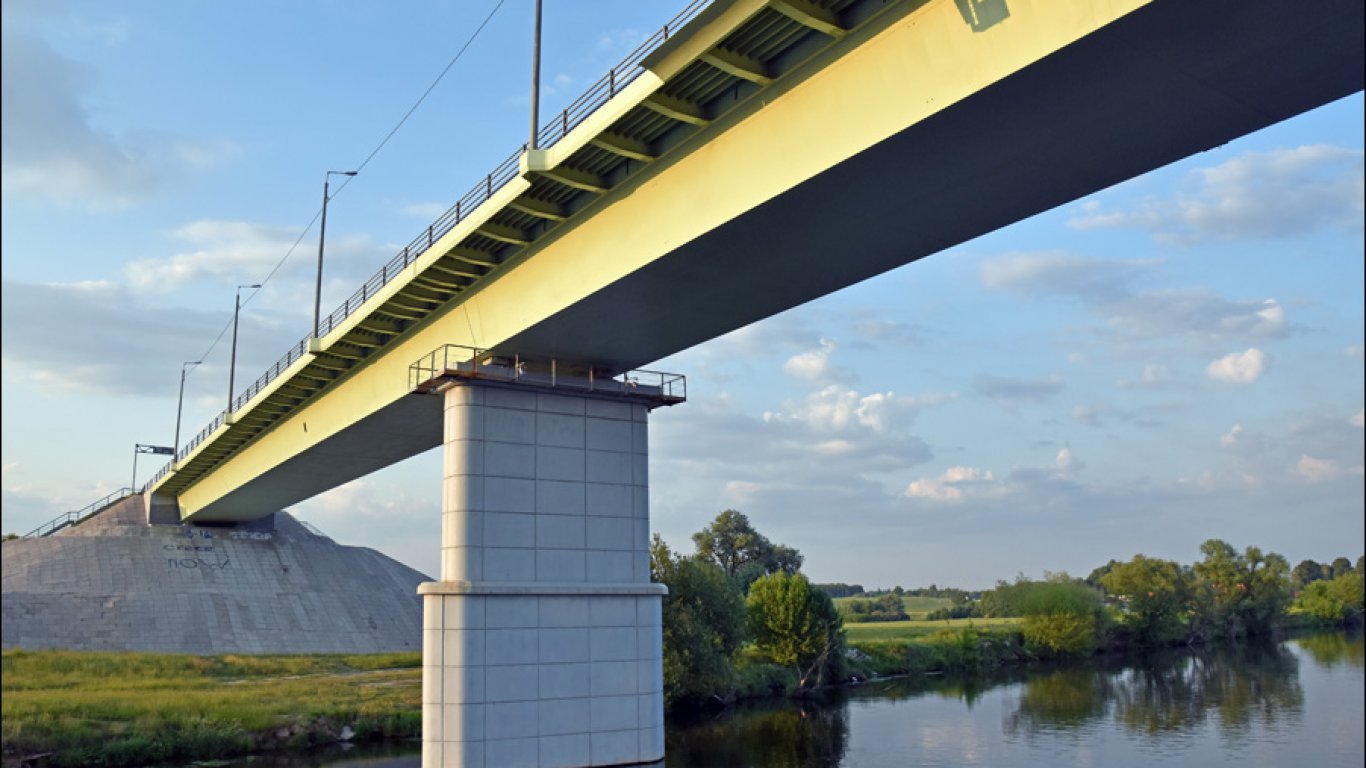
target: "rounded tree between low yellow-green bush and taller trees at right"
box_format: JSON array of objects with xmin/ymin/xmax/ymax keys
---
[{"xmin": 1100, "ymin": 555, "xmax": 1190, "ymax": 645}]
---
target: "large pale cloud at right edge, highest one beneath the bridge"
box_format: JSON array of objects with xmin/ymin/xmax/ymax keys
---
[{"xmin": 1070, "ymin": 145, "xmax": 1363, "ymax": 243}]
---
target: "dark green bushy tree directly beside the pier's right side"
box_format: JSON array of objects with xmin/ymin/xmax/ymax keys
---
[{"xmin": 650, "ymin": 534, "xmax": 744, "ymax": 701}]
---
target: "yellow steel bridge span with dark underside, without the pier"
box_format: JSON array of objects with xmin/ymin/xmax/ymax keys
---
[{"xmin": 149, "ymin": 0, "xmax": 1363, "ymax": 519}]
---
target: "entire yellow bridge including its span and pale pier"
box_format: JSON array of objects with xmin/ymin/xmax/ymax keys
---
[{"xmin": 133, "ymin": 0, "xmax": 1366, "ymax": 765}]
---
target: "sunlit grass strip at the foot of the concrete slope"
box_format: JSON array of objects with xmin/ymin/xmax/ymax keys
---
[{"xmin": 0, "ymin": 650, "xmax": 422, "ymax": 767}]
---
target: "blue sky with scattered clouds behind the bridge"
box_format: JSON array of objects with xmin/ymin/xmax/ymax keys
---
[{"xmin": 0, "ymin": 0, "xmax": 1366, "ymax": 588}]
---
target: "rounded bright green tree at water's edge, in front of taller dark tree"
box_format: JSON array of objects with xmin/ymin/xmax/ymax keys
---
[{"xmin": 746, "ymin": 571, "xmax": 844, "ymax": 689}]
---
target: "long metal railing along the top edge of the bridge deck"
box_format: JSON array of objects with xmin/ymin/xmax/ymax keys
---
[{"xmin": 142, "ymin": 0, "xmax": 713, "ymax": 489}]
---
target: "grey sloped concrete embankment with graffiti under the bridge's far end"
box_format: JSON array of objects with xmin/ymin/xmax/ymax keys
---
[{"xmin": 0, "ymin": 497, "xmax": 429, "ymax": 653}]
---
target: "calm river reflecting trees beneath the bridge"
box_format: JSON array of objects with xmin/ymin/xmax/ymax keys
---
[{"xmin": 224, "ymin": 633, "xmax": 1366, "ymax": 768}]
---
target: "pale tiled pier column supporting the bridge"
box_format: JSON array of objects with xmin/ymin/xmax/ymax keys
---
[{"xmin": 418, "ymin": 380, "xmax": 665, "ymax": 768}]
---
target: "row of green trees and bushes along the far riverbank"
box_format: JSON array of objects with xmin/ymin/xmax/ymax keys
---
[{"xmin": 650, "ymin": 510, "xmax": 1366, "ymax": 702}]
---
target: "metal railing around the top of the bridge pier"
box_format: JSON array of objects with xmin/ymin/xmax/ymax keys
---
[{"xmin": 408, "ymin": 344, "xmax": 687, "ymax": 404}]
